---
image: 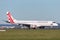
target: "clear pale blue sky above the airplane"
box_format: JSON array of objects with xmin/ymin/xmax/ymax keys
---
[{"xmin": 0, "ymin": 0, "xmax": 60, "ymax": 23}]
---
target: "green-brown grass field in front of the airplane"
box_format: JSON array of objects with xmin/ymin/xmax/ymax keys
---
[{"xmin": 0, "ymin": 29, "xmax": 60, "ymax": 40}]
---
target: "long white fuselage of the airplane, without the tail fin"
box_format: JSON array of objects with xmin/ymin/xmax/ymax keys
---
[{"xmin": 15, "ymin": 20, "xmax": 58, "ymax": 27}]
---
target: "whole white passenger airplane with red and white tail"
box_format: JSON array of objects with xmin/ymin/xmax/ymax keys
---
[{"xmin": 6, "ymin": 12, "xmax": 58, "ymax": 29}]
